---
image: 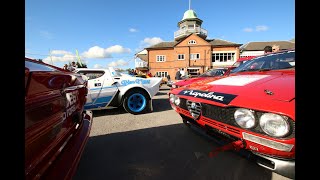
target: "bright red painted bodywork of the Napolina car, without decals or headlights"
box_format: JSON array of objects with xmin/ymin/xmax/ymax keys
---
[{"xmin": 169, "ymin": 51, "xmax": 295, "ymax": 158}]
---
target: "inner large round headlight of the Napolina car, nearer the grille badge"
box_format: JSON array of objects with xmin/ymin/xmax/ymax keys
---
[{"xmin": 234, "ymin": 108, "xmax": 256, "ymax": 128}]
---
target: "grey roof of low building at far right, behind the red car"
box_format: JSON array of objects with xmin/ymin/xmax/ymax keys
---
[{"xmin": 240, "ymin": 41, "xmax": 295, "ymax": 51}]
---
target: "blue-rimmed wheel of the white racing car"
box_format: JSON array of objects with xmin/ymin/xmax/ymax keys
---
[{"xmin": 123, "ymin": 89, "xmax": 150, "ymax": 114}]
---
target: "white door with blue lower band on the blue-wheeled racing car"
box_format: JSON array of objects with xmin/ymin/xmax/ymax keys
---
[{"xmin": 77, "ymin": 70, "xmax": 118, "ymax": 110}]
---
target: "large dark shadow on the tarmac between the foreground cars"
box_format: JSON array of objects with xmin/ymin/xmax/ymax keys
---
[{"xmin": 74, "ymin": 124, "xmax": 272, "ymax": 180}]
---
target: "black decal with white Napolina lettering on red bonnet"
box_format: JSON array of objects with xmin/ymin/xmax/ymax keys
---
[{"xmin": 179, "ymin": 90, "xmax": 237, "ymax": 104}]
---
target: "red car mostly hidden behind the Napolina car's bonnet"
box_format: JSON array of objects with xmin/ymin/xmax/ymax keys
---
[{"xmin": 172, "ymin": 67, "xmax": 228, "ymax": 89}]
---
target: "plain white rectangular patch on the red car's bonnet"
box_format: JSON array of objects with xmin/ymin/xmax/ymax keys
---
[{"xmin": 207, "ymin": 75, "xmax": 269, "ymax": 86}]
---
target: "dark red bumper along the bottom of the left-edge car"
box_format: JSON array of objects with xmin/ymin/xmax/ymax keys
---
[{"xmin": 41, "ymin": 111, "xmax": 93, "ymax": 180}]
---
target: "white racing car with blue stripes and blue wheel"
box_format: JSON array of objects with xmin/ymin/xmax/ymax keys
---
[{"xmin": 75, "ymin": 67, "xmax": 162, "ymax": 114}]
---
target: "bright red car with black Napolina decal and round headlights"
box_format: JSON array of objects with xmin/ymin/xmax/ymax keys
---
[{"xmin": 169, "ymin": 50, "xmax": 296, "ymax": 178}]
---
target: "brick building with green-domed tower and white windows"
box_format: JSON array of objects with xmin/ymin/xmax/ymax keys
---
[{"xmin": 136, "ymin": 9, "xmax": 242, "ymax": 78}]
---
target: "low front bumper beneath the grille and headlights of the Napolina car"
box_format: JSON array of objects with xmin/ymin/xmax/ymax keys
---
[{"xmin": 180, "ymin": 114, "xmax": 295, "ymax": 179}]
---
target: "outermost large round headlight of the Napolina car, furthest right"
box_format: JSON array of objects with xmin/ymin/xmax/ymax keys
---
[{"xmin": 260, "ymin": 113, "xmax": 290, "ymax": 137}]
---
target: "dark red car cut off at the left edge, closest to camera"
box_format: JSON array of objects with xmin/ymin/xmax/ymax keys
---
[{"xmin": 25, "ymin": 58, "xmax": 92, "ymax": 179}]
